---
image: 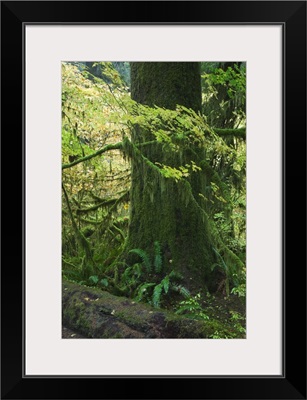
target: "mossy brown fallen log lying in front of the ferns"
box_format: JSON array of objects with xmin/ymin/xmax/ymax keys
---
[{"xmin": 62, "ymin": 281, "xmax": 231, "ymax": 339}]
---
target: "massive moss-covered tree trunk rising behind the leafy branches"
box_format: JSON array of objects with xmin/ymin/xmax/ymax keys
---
[{"xmin": 127, "ymin": 62, "xmax": 214, "ymax": 289}]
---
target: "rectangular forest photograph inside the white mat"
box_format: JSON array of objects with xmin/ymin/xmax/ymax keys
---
[{"xmin": 61, "ymin": 61, "xmax": 247, "ymax": 339}]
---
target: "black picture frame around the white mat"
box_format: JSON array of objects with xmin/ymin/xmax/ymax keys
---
[{"xmin": 1, "ymin": 1, "xmax": 306, "ymax": 399}]
